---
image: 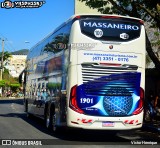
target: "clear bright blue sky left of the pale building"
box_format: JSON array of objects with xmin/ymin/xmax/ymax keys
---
[{"xmin": 0, "ymin": 0, "xmax": 74, "ymax": 52}]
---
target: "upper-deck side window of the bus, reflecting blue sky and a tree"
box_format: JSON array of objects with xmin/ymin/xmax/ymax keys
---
[{"xmin": 27, "ymin": 22, "xmax": 72, "ymax": 59}]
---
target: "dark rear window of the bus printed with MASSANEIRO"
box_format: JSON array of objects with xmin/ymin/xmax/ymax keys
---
[{"xmin": 80, "ymin": 18, "xmax": 141, "ymax": 42}]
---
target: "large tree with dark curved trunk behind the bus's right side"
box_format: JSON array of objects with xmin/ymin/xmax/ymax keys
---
[{"xmin": 79, "ymin": 0, "xmax": 160, "ymax": 70}]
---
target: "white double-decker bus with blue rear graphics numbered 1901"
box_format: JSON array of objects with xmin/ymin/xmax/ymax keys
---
[{"xmin": 21, "ymin": 15, "xmax": 146, "ymax": 131}]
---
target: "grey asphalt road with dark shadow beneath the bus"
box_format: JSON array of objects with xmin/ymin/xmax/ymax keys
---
[{"xmin": 0, "ymin": 99, "xmax": 160, "ymax": 147}]
